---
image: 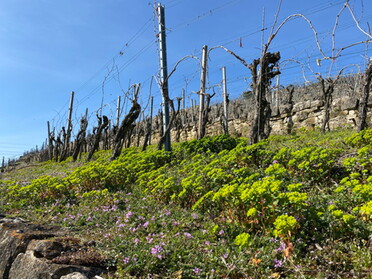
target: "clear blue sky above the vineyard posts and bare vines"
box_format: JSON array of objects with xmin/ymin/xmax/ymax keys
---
[{"xmin": 0, "ymin": 0, "xmax": 372, "ymax": 161}]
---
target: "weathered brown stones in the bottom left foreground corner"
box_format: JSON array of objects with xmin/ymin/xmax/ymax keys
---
[{"xmin": 0, "ymin": 215, "xmax": 105, "ymax": 279}]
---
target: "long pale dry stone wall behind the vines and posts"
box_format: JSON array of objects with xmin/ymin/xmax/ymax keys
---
[{"xmin": 140, "ymin": 94, "xmax": 372, "ymax": 143}]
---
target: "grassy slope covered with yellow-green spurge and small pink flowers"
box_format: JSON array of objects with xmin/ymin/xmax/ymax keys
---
[{"xmin": 0, "ymin": 130, "xmax": 372, "ymax": 278}]
